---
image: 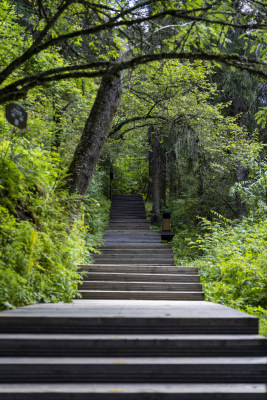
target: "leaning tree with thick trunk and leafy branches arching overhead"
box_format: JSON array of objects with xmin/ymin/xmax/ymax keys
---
[{"xmin": 0, "ymin": 0, "xmax": 267, "ymax": 206}]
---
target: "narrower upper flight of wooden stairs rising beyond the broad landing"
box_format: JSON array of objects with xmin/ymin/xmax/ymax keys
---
[{"xmin": 80, "ymin": 196, "xmax": 204, "ymax": 301}]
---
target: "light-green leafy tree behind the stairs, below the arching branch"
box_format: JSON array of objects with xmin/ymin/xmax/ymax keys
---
[{"xmin": 108, "ymin": 61, "xmax": 262, "ymax": 222}]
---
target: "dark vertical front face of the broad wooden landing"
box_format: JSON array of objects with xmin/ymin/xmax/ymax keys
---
[{"xmin": 0, "ymin": 316, "xmax": 258, "ymax": 335}]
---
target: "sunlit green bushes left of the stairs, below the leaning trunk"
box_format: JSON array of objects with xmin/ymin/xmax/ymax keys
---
[{"xmin": 0, "ymin": 138, "xmax": 109, "ymax": 309}]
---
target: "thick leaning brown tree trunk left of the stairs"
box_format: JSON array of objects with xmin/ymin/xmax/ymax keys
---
[{"xmin": 64, "ymin": 73, "xmax": 122, "ymax": 203}]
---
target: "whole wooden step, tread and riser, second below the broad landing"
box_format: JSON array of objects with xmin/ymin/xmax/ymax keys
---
[{"xmin": 0, "ymin": 357, "xmax": 266, "ymax": 384}]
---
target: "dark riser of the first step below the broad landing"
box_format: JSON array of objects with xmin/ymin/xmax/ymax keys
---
[{"xmin": 0, "ymin": 339, "xmax": 267, "ymax": 357}]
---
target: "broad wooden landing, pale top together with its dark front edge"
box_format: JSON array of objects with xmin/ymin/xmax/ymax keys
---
[{"xmin": 0, "ymin": 300, "xmax": 258, "ymax": 335}]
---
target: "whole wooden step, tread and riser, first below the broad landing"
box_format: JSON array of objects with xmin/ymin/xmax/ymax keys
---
[{"xmin": 0, "ymin": 334, "xmax": 267, "ymax": 357}]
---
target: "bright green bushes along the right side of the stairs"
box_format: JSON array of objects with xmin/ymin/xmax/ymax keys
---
[{"xmin": 184, "ymin": 217, "xmax": 267, "ymax": 335}]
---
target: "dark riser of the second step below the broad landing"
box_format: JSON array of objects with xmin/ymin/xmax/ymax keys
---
[{"xmin": 0, "ymin": 360, "xmax": 266, "ymax": 384}]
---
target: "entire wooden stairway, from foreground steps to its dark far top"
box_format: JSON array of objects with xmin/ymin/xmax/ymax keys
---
[{"xmin": 0, "ymin": 196, "xmax": 267, "ymax": 400}]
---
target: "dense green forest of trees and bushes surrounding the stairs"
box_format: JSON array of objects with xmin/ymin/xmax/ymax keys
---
[{"xmin": 0, "ymin": 0, "xmax": 267, "ymax": 334}]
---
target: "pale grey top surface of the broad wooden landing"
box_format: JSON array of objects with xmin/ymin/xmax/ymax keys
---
[{"xmin": 0, "ymin": 300, "xmax": 258, "ymax": 322}]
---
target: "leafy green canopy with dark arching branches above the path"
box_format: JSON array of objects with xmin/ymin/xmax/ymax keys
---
[{"xmin": 0, "ymin": 0, "xmax": 266, "ymax": 104}]
